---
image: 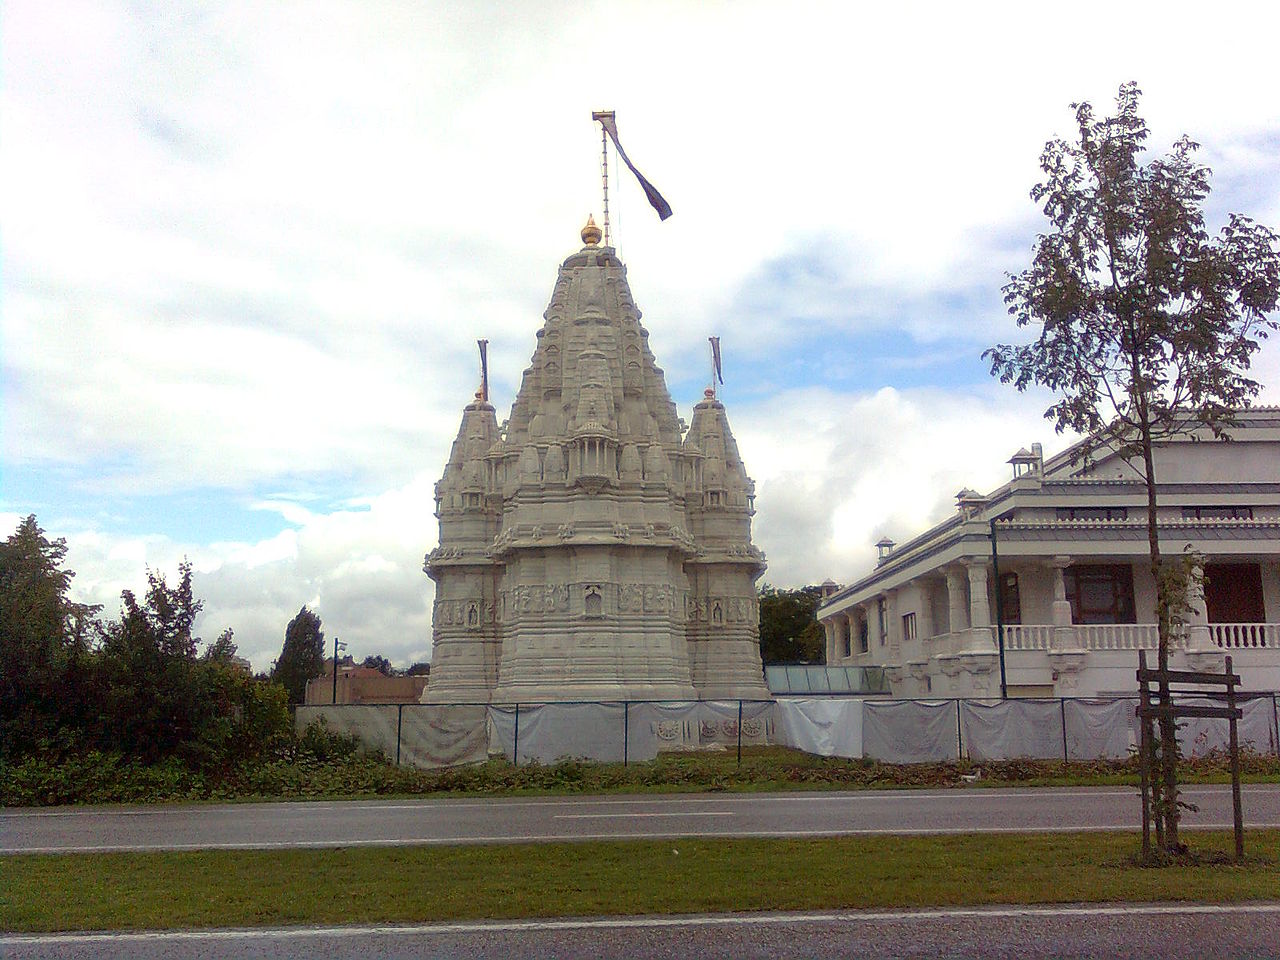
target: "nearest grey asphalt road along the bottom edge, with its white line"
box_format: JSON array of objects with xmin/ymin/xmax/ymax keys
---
[{"xmin": 0, "ymin": 904, "xmax": 1280, "ymax": 960}]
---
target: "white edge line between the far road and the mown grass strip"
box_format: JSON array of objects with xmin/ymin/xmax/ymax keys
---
[{"xmin": 0, "ymin": 822, "xmax": 1280, "ymax": 856}]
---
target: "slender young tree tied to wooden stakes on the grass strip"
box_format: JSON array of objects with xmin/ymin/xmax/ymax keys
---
[{"xmin": 983, "ymin": 83, "xmax": 1280, "ymax": 854}]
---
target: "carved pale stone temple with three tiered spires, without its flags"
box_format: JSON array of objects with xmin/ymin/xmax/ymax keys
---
[{"xmin": 422, "ymin": 221, "xmax": 769, "ymax": 704}]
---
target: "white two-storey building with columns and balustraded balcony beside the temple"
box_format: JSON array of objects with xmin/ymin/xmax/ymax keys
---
[{"xmin": 818, "ymin": 407, "xmax": 1280, "ymax": 696}]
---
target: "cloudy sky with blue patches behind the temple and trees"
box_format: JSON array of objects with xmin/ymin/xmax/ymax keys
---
[{"xmin": 0, "ymin": 0, "xmax": 1280, "ymax": 669}]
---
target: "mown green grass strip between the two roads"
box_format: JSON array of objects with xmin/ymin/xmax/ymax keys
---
[{"xmin": 0, "ymin": 829, "xmax": 1280, "ymax": 932}]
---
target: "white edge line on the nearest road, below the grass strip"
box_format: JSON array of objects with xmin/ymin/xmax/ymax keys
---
[{"xmin": 0, "ymin": 904, "xmax": 1280, "ymax": 946}]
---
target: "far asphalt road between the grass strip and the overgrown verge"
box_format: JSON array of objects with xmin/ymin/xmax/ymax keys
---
[{"xmin": 0, "ymin": 785, "xmax": 1280, "ymax": 854}]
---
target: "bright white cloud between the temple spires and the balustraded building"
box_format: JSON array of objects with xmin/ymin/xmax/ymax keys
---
[{"xmin": 728, "ymin": 387, "xmax": 1065, "ymax": 586}]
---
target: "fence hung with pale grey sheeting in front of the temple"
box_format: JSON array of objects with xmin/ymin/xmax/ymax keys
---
[{"xmin": 296, "ymin": 694, "xmax": 1280, "ymax": 767}]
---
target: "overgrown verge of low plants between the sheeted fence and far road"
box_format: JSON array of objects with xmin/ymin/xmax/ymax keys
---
[{"xmin": 0, "ymin": 741, "xmax": 1280, "ymax": 806}]
